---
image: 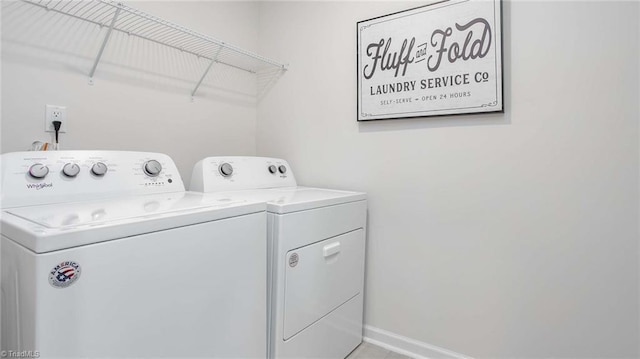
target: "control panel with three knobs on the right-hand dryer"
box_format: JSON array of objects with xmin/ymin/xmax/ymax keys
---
[{"xmin": 189, "ymin": 157, "xmax": 297, "ymax": 192}]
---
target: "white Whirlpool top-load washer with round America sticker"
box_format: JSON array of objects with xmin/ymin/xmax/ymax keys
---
[{"xmin": 1, "ymin": 151, "xmax": 267, "ymax": 358}]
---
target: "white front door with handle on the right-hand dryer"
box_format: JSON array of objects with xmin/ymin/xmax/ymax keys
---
[{"xmin": 284, "ymin": 229, "xmax": 365, "ymax": 340}]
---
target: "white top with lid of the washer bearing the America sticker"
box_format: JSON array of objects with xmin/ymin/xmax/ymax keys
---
[{"xmin": 0, "ymin": 192, "xmax": 266, "ymax": 253}]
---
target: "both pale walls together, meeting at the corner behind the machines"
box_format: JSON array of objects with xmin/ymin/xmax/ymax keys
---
[{"xmin": 0, "ymin": 1, "xmax": 640, "ymax": 357}]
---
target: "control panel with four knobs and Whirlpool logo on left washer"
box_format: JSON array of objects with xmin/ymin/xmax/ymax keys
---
[{"xmin": 0, "ymin": 151, "xmax": 185, "ymax": 208}]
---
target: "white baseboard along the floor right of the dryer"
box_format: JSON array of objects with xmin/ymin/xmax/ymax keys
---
[{"xmin": 363, "ymin": 325, "xmax": 472, "ymax": 359}]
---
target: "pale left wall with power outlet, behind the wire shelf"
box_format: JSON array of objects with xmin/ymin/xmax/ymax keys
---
[{"xmin": 0, "ymin": 1, "xmax": 258, "ymax": 184}]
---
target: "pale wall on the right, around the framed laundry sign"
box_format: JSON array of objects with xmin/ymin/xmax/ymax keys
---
[{"xmin": 257, "ymin": 1, "xmax": 640, "ymax": 357}]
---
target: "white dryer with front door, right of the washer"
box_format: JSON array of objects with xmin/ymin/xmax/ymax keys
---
[{"xmin": 189, "ymin": 157, "xmax": 367, "ymax": 359}]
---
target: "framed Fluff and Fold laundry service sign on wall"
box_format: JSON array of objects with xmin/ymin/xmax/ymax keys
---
[{"xmin": 357, "ymin": 0, "xmax": 503, "ymax": 121}]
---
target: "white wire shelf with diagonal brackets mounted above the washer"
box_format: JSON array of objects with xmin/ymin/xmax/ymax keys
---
[{"xmin": 22, "ymin": 0, "xmax": 287, "ymax": 97}]
